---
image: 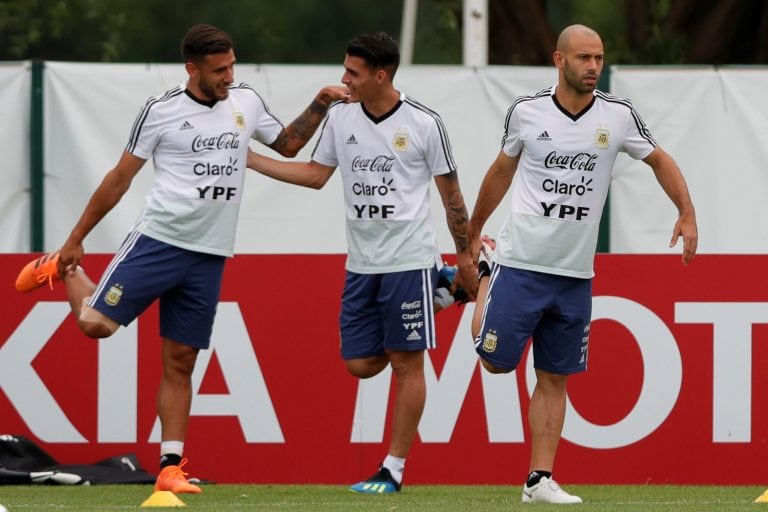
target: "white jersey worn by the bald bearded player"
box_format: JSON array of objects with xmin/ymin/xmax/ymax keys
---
[{"xmin": 494, "ymin": 87, "xmax": 656, "ymax": 278}]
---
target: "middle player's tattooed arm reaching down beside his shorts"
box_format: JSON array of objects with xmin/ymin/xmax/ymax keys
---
[{"xmin": 435, "ymin": 171, "xmax": 477, "ymax": 300}]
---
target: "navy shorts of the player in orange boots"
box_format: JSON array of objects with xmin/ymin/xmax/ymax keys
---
[{"xmin": 90, "ymin": 232, "xmax": 226, "ymax": 349}]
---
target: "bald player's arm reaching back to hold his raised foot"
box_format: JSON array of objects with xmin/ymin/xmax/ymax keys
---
[{"xmin": 469, "ymin": 150, "xmax": 520, "ymax": 262}]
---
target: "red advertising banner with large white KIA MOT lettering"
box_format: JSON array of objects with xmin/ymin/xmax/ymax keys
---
[{"xmin": 0, "ymin": 255, "xmax": 768, "ymax": 485}]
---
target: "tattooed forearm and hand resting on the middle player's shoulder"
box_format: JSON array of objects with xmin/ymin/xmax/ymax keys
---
[{"xmin": 269, "ymin": 85, "xmax": 349, "ymax": 158}]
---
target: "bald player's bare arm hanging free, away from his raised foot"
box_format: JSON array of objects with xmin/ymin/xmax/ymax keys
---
[{"xmin": 643, "ymin": 146, "xmax": 699, "ymax": 265}]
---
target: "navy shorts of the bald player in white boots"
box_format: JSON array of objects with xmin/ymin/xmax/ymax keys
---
[{"xmin": 475, "ymin": 264, "xmax": 592, "ymax": 375}]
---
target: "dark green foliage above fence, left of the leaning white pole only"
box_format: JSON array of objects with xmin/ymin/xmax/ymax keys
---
[{"xmin": 0, "ymin": 0, "xmax": 402, "ymax": 64}]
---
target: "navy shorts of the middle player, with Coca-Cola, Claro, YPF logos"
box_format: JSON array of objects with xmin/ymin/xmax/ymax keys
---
[{"xmin": 339, "ymin": 267, "xmax": 437, "ymax": 359}]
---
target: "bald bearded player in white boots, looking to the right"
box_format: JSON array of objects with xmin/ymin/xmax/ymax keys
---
[{"xmin": 469, "ymin": 25, "xmax": 698, "ymax": 503}]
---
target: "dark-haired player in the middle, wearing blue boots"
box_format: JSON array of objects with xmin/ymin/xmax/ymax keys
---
[{"xmin": 248, "ymin": 32, "xmax": 477, "ymax": 494}]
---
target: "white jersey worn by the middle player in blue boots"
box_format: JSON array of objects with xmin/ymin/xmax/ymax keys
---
[{"xmin": 312, "ymin": 94, "xmax": 456, "ymax": 274}]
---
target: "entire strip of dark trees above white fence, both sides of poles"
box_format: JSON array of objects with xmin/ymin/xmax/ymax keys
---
[{"xmin": 0, "ymin": 0, "xmax": 768, "ymax": 65}]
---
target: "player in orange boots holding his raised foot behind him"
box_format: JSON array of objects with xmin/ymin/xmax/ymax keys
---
[{"xmin": 16, "ymin": 25, "xmax": 347, "ymax": 493}]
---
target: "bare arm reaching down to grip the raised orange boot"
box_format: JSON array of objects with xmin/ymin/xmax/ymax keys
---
[{"xmin": 59, "ymin": 151, "xmax": 146, "ymax": 275}]
